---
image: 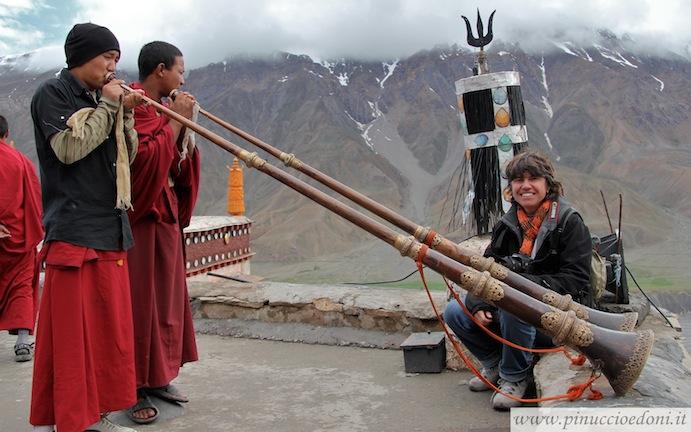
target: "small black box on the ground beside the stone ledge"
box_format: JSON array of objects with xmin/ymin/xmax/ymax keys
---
[{"xmin": 401, "ymin": 332, "xmax": 446, "ymax": 373}]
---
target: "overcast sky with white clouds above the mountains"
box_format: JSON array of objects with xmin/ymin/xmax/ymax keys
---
[{"xmin": 0, "ymin": 0, "xmax": 691, "ymax": 68}]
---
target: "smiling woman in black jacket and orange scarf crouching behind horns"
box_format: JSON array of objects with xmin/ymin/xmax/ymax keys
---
[{"xmin": 444, "ymin": 151, "xmax": 592, "ymax": 410}]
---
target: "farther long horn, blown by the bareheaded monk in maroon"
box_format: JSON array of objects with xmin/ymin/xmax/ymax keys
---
[{"xmin": 171, "ymin": 90, "xmax": 638, "ymax": 331}]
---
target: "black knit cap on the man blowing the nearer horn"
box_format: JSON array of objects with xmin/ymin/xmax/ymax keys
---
[{"xmin": 65, "ymin": 23, "xmax": 120, "ymax": 69}]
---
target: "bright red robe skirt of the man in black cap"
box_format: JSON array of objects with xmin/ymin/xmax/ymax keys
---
[{"xmin": 30, "ymin": 242, "xmax": 137, "ymax": 432}]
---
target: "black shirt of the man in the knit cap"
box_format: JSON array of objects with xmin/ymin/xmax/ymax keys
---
[{"xmin": 31, "ymin": 69, "xmax": 134, "ymax": 251}]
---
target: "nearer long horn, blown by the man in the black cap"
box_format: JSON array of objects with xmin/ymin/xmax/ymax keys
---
[{"xmin": 123, "ymin": 86, "xmax": 654, "ymax": 395}]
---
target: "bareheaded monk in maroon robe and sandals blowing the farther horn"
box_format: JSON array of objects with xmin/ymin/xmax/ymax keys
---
[{"xmin": 128, "ymin": 42, "xmax": 200, "ymax": 423}]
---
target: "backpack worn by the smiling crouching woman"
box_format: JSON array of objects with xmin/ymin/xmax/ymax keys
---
[{"xmin": 555, "ymin": 207, "xmax": 629, "ymax": 306}]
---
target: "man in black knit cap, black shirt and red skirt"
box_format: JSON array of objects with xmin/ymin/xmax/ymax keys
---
[{"xmin": 30, "ymin": 23, "xmax": 142, "ymax": 432}]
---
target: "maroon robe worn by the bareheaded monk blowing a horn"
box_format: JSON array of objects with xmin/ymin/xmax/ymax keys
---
[{"xmin": 128, "ymin": 83, "xmax": 200, "ymax": 388}]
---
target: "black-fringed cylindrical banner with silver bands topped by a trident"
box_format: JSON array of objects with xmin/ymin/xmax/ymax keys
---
[{"xmin": 451, "ymin": 11, "xmax": 528, "ymax": 234}]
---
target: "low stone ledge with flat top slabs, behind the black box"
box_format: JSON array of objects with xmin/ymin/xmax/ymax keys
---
[{"xmin": 188, "ymin": 278, "xmax": 446, "ymax": 334}]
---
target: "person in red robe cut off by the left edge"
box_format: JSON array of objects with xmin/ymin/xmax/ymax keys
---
[{"xmin": 0, "ymin": 116, "xmax": 43, "ymax": 362}]
